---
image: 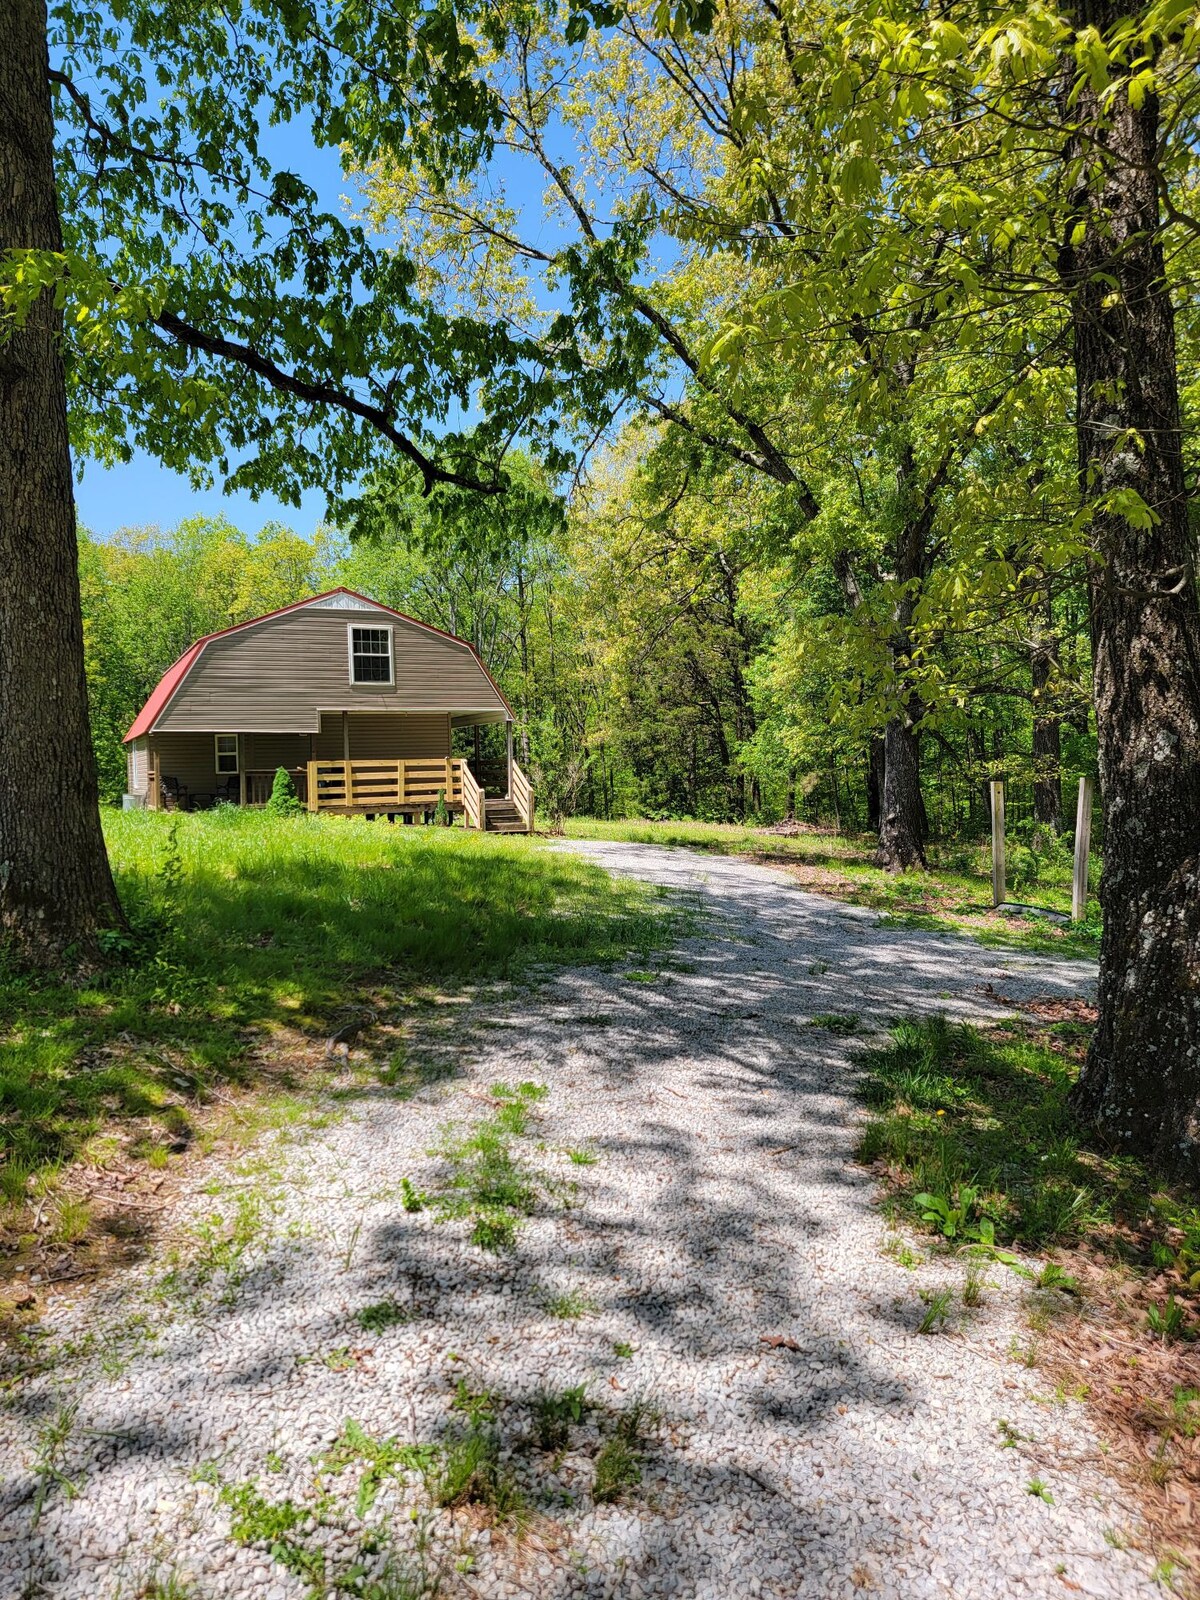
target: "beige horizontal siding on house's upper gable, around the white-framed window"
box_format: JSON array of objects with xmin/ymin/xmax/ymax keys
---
[{"xmin": 157, "ymin": 608, "xmax": 507, "ymax": 732}]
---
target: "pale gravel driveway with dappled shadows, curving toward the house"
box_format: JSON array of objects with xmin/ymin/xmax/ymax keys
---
[{"xmin": 0, "ymin": 843, "xmax": 1160, "ymax": 1600}]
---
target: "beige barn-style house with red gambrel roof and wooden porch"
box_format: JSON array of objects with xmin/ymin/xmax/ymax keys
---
[{"xmin": 125, "ymin": 589, "xmax": 533, "ymax": 832}]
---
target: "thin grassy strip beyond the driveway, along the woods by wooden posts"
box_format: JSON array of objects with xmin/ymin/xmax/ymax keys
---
[{"xmin": 566, "ymin": 818, "xmax": 1099, "ymax": 955}]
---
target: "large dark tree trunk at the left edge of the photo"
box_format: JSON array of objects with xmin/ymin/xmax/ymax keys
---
[{"xmin": 0, "ymin": 0, "xmax": 123, "ymax": 965}]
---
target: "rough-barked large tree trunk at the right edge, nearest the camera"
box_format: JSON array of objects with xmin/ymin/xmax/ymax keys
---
[{"xmin": 1061, "ymin": 5, "xmax": 1200, "ymax": 1179}]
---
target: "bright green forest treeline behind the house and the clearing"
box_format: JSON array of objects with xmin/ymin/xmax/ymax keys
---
[{"xmin": 80, "ymin": 464, "xmax": 1096, "ymax": 835}]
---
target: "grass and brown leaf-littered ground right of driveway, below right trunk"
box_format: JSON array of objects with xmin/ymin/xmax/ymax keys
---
[{"xmin": 859, "ymin": 1002, "xmax": 1200, "ymax": 1594}]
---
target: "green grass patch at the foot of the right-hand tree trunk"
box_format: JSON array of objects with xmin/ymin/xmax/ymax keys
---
[{"xmin": 859, "ymin": 1018, "xmax": 1200, "ymax": 1288}]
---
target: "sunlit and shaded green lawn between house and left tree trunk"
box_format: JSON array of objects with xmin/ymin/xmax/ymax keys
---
[{"xmin": 0, "ymin": 810, "xmax": 675, "ymax": 1286}]
